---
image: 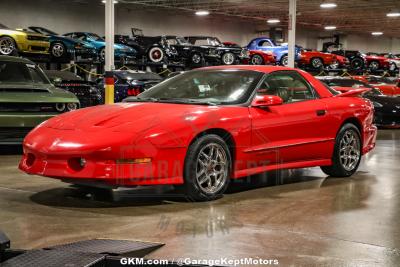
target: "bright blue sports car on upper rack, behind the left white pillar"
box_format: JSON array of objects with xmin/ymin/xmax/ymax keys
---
[{"xmin": 64, "ymin": 32, "xmax": 137, "ymax": 61}]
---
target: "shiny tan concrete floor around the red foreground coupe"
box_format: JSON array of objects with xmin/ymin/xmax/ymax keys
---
[{"xmin": 0, "ymin": 130, "xmax": 400, "ymax": 267}]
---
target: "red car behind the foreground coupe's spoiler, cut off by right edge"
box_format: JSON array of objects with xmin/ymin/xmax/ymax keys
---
[{"xmin": 353, "ymin": 75, "xmax": 400, "ymax": 96}]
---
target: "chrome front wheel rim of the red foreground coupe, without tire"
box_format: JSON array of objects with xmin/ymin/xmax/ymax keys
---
[{"xmin": 196, "ymin": 143, "xmax": 229, "ymax": 194}]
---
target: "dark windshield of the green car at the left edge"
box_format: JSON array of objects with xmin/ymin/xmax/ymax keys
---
[{"xmin": 0, "ymin": 61, "xmax": 50, "ymax": 84}]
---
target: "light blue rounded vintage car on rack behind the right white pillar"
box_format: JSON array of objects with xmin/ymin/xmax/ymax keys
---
[{"xmin": 247, "ymin": 37, "xmax": 301, "ymax": 66}]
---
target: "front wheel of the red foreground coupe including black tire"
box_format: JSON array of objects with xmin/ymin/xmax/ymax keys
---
[{"xmin": 184, "ymin": 134, "xmax": 232, "ymax": 201}]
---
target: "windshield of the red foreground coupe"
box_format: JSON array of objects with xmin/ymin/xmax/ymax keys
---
[{"xmin": 138, "ymin": 70, "xmax": 263, "ymax": 104}]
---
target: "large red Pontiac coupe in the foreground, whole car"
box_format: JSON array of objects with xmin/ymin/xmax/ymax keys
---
[{"xmin": 19, "ymin": 66, "xmax": 377, "ymax": 201}]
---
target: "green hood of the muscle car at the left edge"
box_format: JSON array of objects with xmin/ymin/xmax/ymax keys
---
[{"xmin": 0, "ymin": 83, "xmax": 78, "ymax": 103}]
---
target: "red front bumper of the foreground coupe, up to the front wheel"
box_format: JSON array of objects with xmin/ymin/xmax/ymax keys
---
[{"xmin": 19, "ymin": 126, "xmax": 186, "ymax": 186}]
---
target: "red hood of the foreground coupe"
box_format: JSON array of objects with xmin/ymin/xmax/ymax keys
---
[{"xmin": 45, "ymin": 102, "xmax": 223, "ymax": 133}]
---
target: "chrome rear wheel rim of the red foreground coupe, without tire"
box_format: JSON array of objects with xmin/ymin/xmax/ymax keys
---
[{"xmin": 340, "ymin": 130, "xmax": 361, "ymax": 171}]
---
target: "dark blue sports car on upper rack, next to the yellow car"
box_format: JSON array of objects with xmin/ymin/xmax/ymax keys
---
[{"xmin": 28, "ymin": 26, "xmax": 97, "ymax": 61}]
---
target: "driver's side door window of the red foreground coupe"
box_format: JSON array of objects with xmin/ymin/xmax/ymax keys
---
[{"xmin": 257, "ymin": 71, "xmax": 317, "ymax": 103}]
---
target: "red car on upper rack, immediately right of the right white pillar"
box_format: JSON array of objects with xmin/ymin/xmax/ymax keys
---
[{"xmin": 298, "ymin": 50, "xmax": 349, "ymax": 69}]
